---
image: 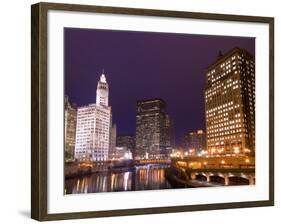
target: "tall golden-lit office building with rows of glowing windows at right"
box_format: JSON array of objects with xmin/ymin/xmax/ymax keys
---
[{"xmin": 205, "ymin": 48, "xmax": 255, "ymax": 155}]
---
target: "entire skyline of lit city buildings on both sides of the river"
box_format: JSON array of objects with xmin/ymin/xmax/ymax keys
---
[{"xmin": 65, "ymin": 48, "xmax": 255, "ymax": 161}]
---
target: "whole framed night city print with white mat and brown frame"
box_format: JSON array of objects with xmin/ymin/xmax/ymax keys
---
[{"xmin": 31, "ymin": 3, "xmax": 274, "ymax": 221}]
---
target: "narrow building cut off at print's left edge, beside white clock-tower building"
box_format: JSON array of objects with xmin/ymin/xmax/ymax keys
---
[{"xmin": 64, "ymin": 96, "xmax": 77, "ymax": 160}]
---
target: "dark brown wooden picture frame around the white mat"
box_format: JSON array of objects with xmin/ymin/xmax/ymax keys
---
[{"xmin": 31, "ymin": 3, "xmax": 274, "ymax": 221}]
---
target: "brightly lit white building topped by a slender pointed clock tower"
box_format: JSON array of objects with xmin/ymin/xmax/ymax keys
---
[{"xmin": 75, "ymin": 74, "xmax": 111, "ymax": 161}]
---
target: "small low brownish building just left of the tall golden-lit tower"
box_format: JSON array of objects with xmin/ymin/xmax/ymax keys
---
[{"xmin": 184, "ymin": 130, "xmax": 206, "ymax": 155}]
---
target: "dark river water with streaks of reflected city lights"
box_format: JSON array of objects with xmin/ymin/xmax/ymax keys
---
[{"xmin": 65, "ymin": 165, "xmax": 171, "ymax": 194}]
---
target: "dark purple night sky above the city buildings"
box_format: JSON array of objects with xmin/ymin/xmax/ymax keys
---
[{"xmin": 64, "ymin": 28, "xmax": 255, "ymax": 143}]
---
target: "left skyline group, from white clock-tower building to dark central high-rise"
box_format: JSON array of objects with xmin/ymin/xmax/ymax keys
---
[{"xmin": 65, "ymin": 73, "xmax": 175, "ymax": 161}]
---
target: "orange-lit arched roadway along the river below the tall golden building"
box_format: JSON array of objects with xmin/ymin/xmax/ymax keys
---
[{"xmin": 168, "ymin": 156, "xmax": 255, "ymax": 186}]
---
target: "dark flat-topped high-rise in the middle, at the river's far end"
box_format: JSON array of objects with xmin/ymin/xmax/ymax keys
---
[{"xmin": 136, "ymin": 98, "xmax": 173, "ymax": 159}]
